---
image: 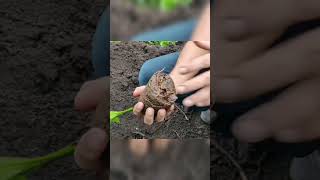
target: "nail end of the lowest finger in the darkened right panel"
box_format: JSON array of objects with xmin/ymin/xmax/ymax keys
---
[{"xmin": 232, "ymin": 119, "xmax": 271, "ymax": 143}]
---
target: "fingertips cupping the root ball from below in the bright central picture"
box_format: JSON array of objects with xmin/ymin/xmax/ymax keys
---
[{"xmin": 133, "ymin": 86, "xmax": 174, "ymax": 125}]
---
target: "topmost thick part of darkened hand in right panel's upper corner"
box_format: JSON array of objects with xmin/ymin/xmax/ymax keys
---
[{"xmin": 213, "ymin": 0, "xmax": 320, "ymax": 72}]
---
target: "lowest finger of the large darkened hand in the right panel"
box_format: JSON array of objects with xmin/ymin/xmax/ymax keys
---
[{"xmin": 232, "ymin": 80, "xmax": 320, "ymax": 142}]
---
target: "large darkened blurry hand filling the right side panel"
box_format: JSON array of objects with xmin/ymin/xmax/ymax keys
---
[{"xmin": 213, "ymin": 0, "xmax": 320, "ymax": 142}]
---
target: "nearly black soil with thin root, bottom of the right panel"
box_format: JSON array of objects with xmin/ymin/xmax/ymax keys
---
[{"xmin": 210, "ymin": 137, "xmax": 290, "ymax": 180}]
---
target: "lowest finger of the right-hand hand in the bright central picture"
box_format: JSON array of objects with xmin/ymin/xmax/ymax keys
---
[{"xmin": 182, "ymin": 86, "xmax": 210, "ymax": 107}]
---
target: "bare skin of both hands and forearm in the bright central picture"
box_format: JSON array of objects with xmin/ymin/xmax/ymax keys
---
[{"xmin": 133, "ymin": 41, "xmax": 210, "ymax": 125}]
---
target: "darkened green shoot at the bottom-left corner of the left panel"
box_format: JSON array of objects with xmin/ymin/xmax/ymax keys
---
[{"xmin": 0, "ymin": 145, "xmax": 75, "ymax": 180}]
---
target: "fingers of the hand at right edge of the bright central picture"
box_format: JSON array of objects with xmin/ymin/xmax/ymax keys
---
[{"xmin": 176, "ymin": 41, "xmax": 210, "ymax": 107}]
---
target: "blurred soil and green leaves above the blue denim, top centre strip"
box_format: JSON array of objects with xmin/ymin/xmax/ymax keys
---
[{"xmin": 110, "ymin": 0, "xmax": 209, "ymax": 40}]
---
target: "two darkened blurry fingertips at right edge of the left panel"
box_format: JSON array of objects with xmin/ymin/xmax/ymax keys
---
[{"xmin": 75, "ymin": 77, "xmax": 108, "ymax": 173}]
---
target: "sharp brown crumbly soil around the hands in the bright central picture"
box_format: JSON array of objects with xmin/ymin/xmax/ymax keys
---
[{"xmin": 110, "ymin": 42, "xmax": 210, "ymax": 139}]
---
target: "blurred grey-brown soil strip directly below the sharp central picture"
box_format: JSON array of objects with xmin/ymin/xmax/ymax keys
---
[{"xmin": 110, "ymin": 140, "xmax": 210, "ymax": 180}]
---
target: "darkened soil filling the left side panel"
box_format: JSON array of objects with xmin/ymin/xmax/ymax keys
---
[{"xmin": 0, "ymin": 0, "xmax": 105, "ymax": 180}]
